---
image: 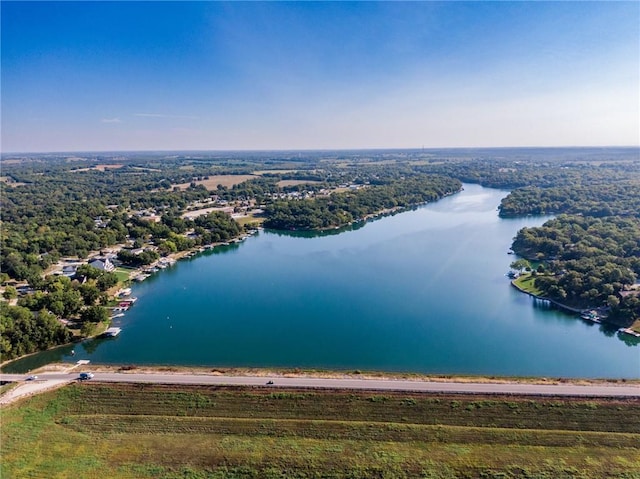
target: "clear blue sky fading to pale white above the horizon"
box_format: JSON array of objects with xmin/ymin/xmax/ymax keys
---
[{"xmin": 0, "ymin": 0, "xmax": 640, "ymax": 153}]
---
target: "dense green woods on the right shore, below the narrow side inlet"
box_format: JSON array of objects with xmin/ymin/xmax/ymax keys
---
[{"xmin": 513, "ymin": 215, "xmax": 640, "ymax": 326}]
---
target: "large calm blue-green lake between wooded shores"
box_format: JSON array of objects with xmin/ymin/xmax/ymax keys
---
[{"xmin": 5, "ymin": 184, "xmax": 640, "ymax": 378}]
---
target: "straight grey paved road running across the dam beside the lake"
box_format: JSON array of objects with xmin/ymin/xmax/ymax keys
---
[{"xmin": 0, "ymin": 373, "xmax": 640, "ymax": 397}]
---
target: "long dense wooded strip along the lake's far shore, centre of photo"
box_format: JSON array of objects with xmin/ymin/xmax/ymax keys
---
[{"xmin": 264, "ymin": 175, "xmax": 462, "ymax": 230}]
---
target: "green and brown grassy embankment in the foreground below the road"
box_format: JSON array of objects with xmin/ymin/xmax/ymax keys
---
[{"xmin": 0, "ymin": 382, "xmax": 640, "ymax": 479}]
